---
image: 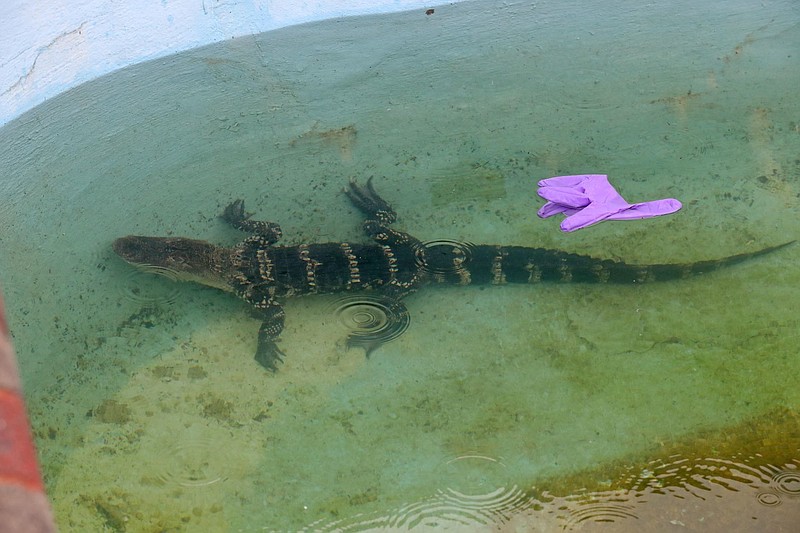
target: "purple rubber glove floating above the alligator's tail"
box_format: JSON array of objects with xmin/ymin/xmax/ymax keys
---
[{"xmin": 538, "ymin": 174, "xmax": 682, "ymax": 231}]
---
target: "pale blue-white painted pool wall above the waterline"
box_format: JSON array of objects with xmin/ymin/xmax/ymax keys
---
[{"xmin": 0, "ymin": 0, "xmax": 456, "ymax": 126}]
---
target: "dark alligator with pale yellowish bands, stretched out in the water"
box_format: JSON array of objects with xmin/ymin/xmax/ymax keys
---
[{"xmin": 113, "ymin": 178, "xmax": 794, "ymax": 372}]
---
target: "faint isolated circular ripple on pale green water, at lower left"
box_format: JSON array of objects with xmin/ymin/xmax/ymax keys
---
[{"xmin": 158, "ymin": 439, "xmax": 226, "ymax": 487}]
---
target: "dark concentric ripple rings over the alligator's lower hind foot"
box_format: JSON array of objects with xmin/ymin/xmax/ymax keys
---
[{"xmin": 332, "ymin": 294, "xmax": 411, "ymax": 350}]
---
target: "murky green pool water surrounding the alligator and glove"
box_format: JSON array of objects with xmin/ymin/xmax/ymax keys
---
[{"xmin": 0, "ymin": 1, "xmax": 800, "ymax": 531}]
